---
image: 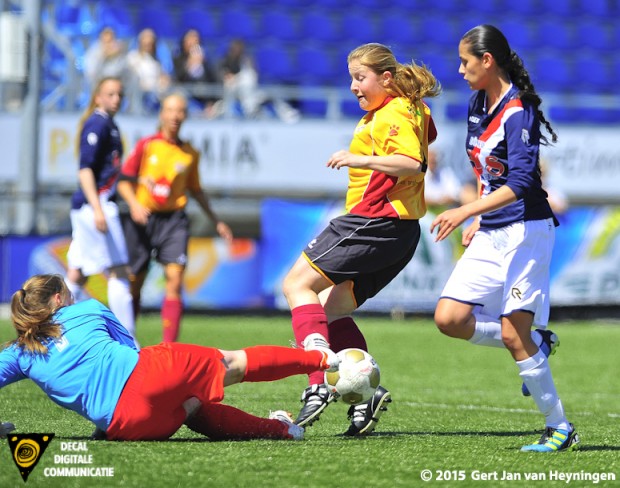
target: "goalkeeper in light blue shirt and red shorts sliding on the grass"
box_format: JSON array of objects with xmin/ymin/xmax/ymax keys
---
[{"xmin": 0, "ymin": 275, "xmax": 338, "ymax": 441}]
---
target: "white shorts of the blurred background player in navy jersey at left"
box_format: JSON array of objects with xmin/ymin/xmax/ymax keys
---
[{"xmin": 67, "ymin": 199, "xmax": 129, "ymax": 276}]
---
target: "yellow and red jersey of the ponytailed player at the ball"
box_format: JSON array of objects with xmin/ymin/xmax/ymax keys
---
[{"xmin": 346, "ymin": 97, "xmax": 437, "ymax": 219}]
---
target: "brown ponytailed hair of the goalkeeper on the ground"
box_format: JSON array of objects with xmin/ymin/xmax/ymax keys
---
[{"xmin": 10, "ymin": 274, "xmax": 71, "ymax": 354}]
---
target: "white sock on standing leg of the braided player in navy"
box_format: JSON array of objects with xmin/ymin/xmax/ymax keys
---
[{"xmin": 517, "ymin": 351, "xmax": 570, "ymax": 430}]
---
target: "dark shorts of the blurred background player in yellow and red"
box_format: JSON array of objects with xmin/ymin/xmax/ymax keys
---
[{"xmin": 123, "ymin": 210, "xmax": 189, "ymax": 275}]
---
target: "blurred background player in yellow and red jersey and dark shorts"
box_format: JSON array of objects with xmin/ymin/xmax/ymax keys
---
[{"xmin": 118, "ymin": 93, "xmax": 233, "ymax": 342}]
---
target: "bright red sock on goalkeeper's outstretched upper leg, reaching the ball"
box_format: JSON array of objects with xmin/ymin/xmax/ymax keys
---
[{"xmin": 243, "ymin": 346, "xmax": 323, "ymax": 382}]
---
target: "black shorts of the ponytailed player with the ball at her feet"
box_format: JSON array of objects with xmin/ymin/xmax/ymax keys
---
[{"xmin": 304, "ymin": 214, "xmax": 420, "ymax": 307}]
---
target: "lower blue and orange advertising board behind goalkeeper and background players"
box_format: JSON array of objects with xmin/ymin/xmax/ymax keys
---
[{"xmin": 0, "ymin": 236, "xmax": 264, "ymax": 309}]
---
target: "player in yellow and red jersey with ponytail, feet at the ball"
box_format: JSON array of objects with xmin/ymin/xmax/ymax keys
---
[{"xmin": 283, "ymin": 43, "xmax": 440, "ymax": 435}]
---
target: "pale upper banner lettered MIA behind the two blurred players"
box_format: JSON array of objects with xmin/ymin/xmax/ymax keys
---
[{"xmin": 36, "ymin": 114, "xmax": 353, "ymax": 194}]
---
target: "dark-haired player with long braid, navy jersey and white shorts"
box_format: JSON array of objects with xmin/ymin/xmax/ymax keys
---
[{"xmin": 431, "ymin": 25, "xmax": 579, "ymax": 452}]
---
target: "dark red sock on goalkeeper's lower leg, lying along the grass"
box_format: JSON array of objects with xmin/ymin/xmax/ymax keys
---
[{"xmin": 185, "ymin": 403, "xmax": 291, "ymax": 441}]
